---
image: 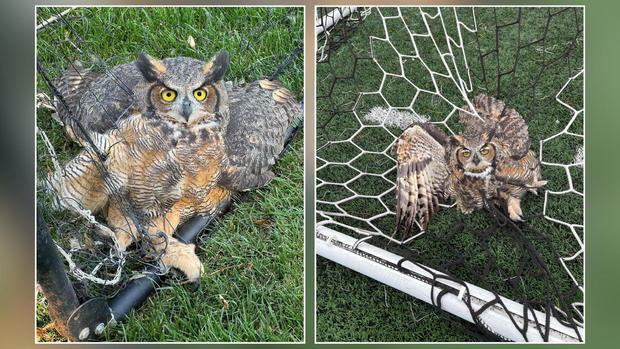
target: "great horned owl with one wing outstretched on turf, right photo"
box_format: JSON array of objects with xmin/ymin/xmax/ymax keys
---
[{"xmin": 392, "ymin": 95, "xmax": 547, "ymax": 235}]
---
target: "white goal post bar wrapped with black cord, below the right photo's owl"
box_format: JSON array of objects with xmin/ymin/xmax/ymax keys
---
[{"xmin": 315, "ymin": 225, "xmax": 585, "ymax": 342}]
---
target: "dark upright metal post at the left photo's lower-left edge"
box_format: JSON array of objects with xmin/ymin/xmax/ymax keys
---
[{"xmin": 37, "ymin": 207, "xmax": 79, "ymax": 340}]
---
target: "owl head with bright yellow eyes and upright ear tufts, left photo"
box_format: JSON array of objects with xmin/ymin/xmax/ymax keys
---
[{"xmin": 136, "ymin": 51, "xmax": 229, "ymax": 127}]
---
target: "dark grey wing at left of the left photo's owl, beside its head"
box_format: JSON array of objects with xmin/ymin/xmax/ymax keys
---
[{"xmin": 55, "ymin": 63, "xmax": 143, "ymax": 144}]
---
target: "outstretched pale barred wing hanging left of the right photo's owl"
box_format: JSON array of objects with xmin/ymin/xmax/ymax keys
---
[{"xmin": 392, "ymin": 123, "xmax": 448, "ymax": 236}]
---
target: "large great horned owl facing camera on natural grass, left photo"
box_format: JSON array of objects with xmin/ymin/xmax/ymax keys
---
[{"xmin": 49, "ymin": 51, "xmax": 301, "ymax": 280}]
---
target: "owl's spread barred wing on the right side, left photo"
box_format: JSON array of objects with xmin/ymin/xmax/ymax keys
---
[{"xmin": 220, "ymin": 80, "xmax": 302, "ymax": 191}]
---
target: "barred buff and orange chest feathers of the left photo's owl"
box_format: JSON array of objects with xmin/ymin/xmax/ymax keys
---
[{"xmin": 112, "ymin": 115, "xmax": 227, "ymax": 215}]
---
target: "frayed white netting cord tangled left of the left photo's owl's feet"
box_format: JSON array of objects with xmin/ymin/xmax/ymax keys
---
[{"xmin": 37, "ymin": 128, "xmax": 125, "ymax": 285}]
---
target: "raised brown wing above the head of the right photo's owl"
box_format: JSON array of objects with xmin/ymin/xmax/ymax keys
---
[{"xmin": 473, "ymin": 95, "xmax": 530, "ymax": 160}]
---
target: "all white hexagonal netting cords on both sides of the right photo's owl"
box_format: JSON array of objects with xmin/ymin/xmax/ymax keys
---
[{"xmin": 316, "ymin": 4, "xmax": 585, "ymax": 325}]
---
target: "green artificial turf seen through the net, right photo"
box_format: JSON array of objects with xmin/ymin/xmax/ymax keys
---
[{"xmin": 317, "ymin": 7, "xmax": 583, "ymax": 341}]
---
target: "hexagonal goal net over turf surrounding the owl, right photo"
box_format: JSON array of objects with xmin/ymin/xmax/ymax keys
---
[{"xmin": 316, "ymin": 7, "xmax": 585, "ymax": 342}]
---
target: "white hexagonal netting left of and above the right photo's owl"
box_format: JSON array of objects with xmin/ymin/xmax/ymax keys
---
[{"xmin": 317, "ymin": 8, "xmax": 476, "ymax": 244}]
